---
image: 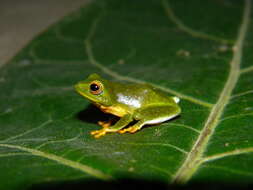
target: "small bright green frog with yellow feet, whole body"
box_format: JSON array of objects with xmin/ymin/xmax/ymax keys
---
[{"xmin": 75, "ymin": 74, "xmax": 181, "ymax": 138}]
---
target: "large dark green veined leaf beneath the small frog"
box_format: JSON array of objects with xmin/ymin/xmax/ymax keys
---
[{"xmin": 0, "ymin": 0, "xmax": 253, "ymax": 189}]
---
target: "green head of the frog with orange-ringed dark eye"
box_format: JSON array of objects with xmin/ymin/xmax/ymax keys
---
[{"xmin": 75, "ymin": 74, "xmax": 111, "ymax": 106}]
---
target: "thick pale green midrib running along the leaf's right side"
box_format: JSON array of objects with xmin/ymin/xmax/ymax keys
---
[{"xmin": 173, "ymin": 0, "xmax": 250, "ymax": 183}]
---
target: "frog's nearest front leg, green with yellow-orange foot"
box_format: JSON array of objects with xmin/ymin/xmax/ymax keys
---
[{"xmin": 91, "ymin": 114, "xmax": 133, "ymax": 138}]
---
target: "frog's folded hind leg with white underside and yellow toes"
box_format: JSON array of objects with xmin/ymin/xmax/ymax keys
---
[{"xmin": 118, "ymin": 105, "xmax": 180, "ymax": 133}]
